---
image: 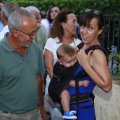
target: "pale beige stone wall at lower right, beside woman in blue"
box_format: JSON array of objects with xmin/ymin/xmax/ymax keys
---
[{"xmin": 94, "ymin": 83, "xmax": 120, "ymax": 120}]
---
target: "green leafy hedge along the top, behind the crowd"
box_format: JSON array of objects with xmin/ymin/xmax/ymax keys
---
[{"xmin": 3, "ymin": 0, "xmax": 120, "ymax": 15}]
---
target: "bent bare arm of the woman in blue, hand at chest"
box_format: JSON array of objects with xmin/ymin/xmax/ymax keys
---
[{"xmin": 78, "ymin": 49, "xmax": 112, "ymax": 92}]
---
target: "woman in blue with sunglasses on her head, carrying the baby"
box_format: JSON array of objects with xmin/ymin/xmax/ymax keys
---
[{"xmin": 68, "ymin": 9, "xmax": 112, "ymax": 120}]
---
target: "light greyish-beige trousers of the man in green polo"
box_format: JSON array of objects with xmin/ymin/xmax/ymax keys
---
[{"xmin": 0, "ymin": 108, "xmax": 42, "ymax": 120}]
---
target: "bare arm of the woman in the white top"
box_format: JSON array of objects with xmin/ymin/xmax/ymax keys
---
[{"xmin": 44, "ymin": 49, "xmax": 54, "ymax": 79}]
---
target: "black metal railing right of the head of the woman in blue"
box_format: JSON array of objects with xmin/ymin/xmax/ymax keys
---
[{"xmin": 103, "ymin": 15, "xmax": 120, "ymax": 52}]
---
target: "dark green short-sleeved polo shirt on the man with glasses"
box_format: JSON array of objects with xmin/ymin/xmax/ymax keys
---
[{"xmin": 0, "ymin": 33, "xmax": 44, "ymax": 113}]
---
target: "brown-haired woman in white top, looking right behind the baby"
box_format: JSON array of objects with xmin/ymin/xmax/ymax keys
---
[{"xmin": 44, "ymin": 10, "xmax": 81, "ymax": 120}]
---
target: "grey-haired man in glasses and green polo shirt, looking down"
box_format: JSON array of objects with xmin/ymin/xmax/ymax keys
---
[{"xmin": 0, "ymin": 9, "xmax": 47, "ymax": 120}]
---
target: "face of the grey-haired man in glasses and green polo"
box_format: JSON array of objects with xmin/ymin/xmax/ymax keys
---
[{"xmin": 14, "ymin": 17, "xmax": 39, "ymax": 47}]
